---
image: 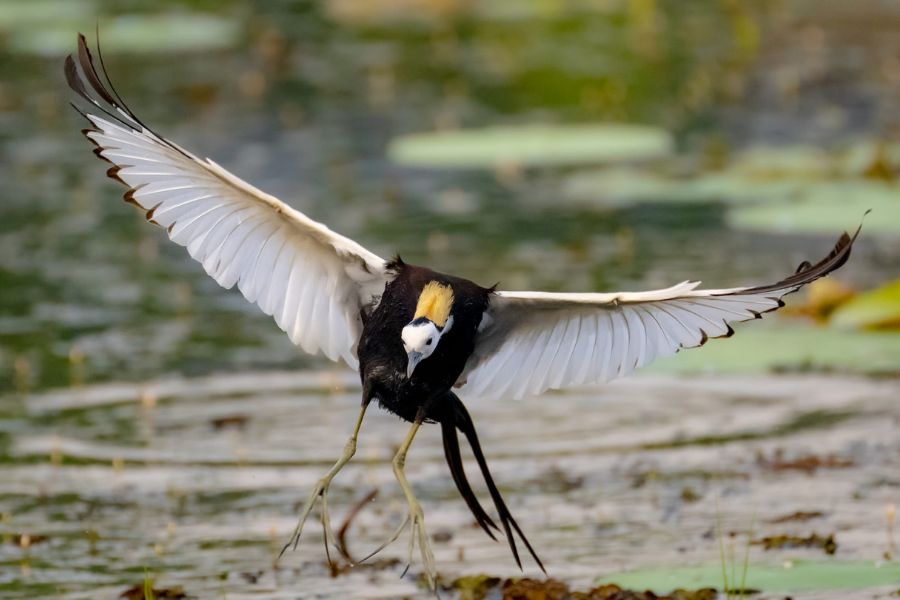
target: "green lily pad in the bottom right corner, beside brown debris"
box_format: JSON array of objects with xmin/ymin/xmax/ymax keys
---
[{"xmin": 597, "ymin": 561, "xmax": 900, "ymax": 593}]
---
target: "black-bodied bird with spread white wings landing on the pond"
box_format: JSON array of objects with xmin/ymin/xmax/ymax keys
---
[{"xmin": 64, "ymin": 34, "xmax": 861, "ymax": 589}]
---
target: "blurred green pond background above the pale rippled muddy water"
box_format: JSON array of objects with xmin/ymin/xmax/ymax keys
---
[{"xmin": 0, "ymin": 0, "xmax": 900, "ymax": 391}]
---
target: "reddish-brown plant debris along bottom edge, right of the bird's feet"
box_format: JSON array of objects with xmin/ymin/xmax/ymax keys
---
[{"xmin": 451, "ymin": 575, "xmax": 718, "ymax": 600}]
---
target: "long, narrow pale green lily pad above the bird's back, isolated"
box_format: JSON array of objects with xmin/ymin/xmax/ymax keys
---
[{"xmin": 388, "ymin": 124, "xmax": 672, "ymax": 169}]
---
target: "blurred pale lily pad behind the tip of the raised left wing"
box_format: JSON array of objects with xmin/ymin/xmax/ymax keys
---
[{"xmin": 7, "ymin": 13, "xmax": 241, "ymax": 57}]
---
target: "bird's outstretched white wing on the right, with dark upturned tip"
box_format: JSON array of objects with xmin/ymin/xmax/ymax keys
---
[{"xmin": 457, "ymin": 229, "xmax": 859, "ymax": 398}]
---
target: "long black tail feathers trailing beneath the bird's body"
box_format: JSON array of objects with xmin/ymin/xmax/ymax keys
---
[{"xmin": 441, "ymin": 393, "xmax": 547, "ymax": 574}]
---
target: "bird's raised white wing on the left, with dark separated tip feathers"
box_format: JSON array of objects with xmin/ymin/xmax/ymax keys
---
[{"xmin": 65, "ymin": 35, "xmax": 392, "ymax": 367}]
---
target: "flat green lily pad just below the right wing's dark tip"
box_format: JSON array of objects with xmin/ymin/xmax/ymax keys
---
[{"xmin": 646, "ymin": 323, "xmax": 900, "ymax": 375}]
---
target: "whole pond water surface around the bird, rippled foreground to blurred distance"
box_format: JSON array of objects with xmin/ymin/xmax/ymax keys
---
[{"xmin": 0, "ymin": 0, "xmax": 900, "ymax": 598}]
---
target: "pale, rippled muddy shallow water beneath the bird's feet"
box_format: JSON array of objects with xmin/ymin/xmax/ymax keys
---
[{"xmin": 0, "ymin": 372, "xmax": 900, "ymax": 598}]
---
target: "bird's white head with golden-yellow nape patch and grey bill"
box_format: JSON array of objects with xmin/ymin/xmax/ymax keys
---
[{"xmin": 400, "ymin": 281, "xmax": 453, "ymax": 378}]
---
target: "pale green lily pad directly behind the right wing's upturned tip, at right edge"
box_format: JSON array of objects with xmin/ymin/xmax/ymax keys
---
[{"xmin": 727, "ymin": 181, "xmax": 900, "ymax": 236}]
